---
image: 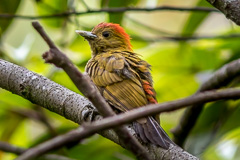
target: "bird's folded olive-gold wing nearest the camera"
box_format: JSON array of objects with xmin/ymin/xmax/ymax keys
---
[{"xmin": 86, "ymin": 53, "xmax": 148, "ymax": 111}]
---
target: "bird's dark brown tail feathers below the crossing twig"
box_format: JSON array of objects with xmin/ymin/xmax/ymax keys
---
[{"xmin": 133, "ymin": 117, "xmax": 174, "ymax": 149}]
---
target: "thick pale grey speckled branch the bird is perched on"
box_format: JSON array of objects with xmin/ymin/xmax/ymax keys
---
[{"xmin": 0, "ymin": 56, "xmax": 197, "ymax": 160}]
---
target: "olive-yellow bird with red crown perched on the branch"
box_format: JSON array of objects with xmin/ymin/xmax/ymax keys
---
[{"xmin": 76, "ymin": 22, "xmax": 173, "ymax": 149}]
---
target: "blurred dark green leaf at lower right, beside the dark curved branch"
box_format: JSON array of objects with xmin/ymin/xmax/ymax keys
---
[{"xmin": 185, "ymin": 101, "xmax": 236, "ymax": 154}]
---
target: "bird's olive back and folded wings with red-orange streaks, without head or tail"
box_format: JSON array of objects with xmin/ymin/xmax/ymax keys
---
[{"xmin": 86, "ymin": 51, "xmax": 157, "ymax": 111}]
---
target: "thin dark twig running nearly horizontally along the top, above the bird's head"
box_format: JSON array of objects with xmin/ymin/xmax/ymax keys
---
[{"xmin": 0, "ymin": 6, "xmax": 219, "ymax": 20}]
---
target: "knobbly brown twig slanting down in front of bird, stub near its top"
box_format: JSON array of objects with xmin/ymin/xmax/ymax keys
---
[{"xmin": 27, "ymin": 22, "xmax": 150, "ymax": 160}]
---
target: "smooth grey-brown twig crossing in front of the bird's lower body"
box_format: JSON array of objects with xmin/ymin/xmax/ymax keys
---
[{"xmin": 12, "ymin": 89, "xmax": 240, "ymax": 160}]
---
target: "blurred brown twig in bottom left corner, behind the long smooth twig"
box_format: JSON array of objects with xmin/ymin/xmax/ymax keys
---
[{"xmin": 0, "ymin": 141, "xmax": 76, "ymax": 160}]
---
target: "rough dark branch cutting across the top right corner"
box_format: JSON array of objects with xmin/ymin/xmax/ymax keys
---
[{"xmin": 207, "ymin": 0, "xmax": 240, "ymax": 25}]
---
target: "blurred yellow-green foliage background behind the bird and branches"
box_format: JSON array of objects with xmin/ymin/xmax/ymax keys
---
[{"xmin": 0, "ymin": 0, "xmax": 240, "ymax": 160}]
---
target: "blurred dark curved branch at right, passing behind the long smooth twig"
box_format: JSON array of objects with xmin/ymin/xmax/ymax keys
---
[{"xmin": 172, "ymin": 59, "xmax": 240, "ymax": 146}]
